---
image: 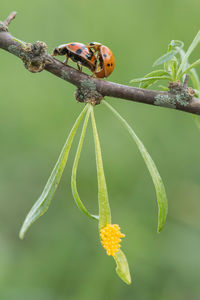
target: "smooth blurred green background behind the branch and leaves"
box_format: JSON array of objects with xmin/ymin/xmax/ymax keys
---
[{"xmin": 0, "ymin": 0, "xmax": 200, "ymax": 300}]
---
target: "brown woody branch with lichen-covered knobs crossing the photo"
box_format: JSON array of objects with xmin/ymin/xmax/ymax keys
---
[{"xmin": 0, "ymin": 12, "xmax": 200, "ymax": 115}]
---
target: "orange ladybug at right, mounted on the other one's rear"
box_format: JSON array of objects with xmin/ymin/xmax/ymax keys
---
[{"xmin": 87, "ymin": 42, "xmax": 115, "ymax": 78}]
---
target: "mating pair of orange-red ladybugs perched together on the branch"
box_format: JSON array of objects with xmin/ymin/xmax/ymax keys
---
[{"xmin": 52, "ymin": 42, "xmax": 115, "ymax": 78}]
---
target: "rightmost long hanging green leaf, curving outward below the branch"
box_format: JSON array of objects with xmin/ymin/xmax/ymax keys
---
[{"xmin": 102, "ymin": 100, "xmax": 168, "ymax": 232}]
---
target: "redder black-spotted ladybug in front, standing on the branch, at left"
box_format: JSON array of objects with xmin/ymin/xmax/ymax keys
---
[{"xmin": 51, "ymin": 43, "xmax": 97, "ymax": 72}]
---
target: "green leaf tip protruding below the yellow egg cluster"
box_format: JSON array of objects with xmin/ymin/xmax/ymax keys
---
[{"xmin": 114, "ymin": 249, "xmax": 131, "ymax": 284}]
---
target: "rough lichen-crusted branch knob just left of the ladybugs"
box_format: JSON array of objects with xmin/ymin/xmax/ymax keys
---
[{"xmin": 20, "ymin": 41, "xmax": 47, "ymax": 73}]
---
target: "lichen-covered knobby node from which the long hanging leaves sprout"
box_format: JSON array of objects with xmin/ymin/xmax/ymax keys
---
[{"xmin": 75, "ymin": 79, "xmax": 103, "ymax": 106}]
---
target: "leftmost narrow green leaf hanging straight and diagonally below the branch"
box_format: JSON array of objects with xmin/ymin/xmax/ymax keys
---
[{"xmin": 19, "ymin": 104, "xmax": 89, "ymax": 239}]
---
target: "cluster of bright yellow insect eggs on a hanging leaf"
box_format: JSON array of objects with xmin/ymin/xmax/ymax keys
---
[{"xmin": 100, "ymin": 224, "xmax": 125, "ymax": 256}]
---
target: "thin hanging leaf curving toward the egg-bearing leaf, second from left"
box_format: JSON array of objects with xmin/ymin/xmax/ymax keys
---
[{"xmin": 71, "ymin": 105, "xmax": 99, "ymax": 220}]
